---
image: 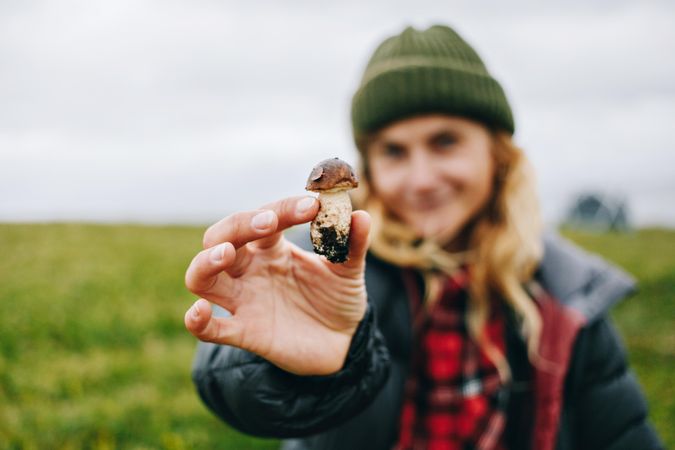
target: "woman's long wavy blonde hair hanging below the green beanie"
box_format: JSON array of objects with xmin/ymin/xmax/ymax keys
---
[{"xmin": 353, "ymin": 132, "xmax": 543, "ymax": 381}]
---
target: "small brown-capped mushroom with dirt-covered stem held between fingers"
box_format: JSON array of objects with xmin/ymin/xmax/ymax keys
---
[{"xmin": 305, "ymin": 158, "xmax": 359, "ymax": 263}]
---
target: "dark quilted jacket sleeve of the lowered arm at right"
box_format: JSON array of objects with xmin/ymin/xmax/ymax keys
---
[{"xmin": 572, "ymin": 318, "xmax": 663, "ymax": 450}]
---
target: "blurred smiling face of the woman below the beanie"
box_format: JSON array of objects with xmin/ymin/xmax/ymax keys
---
[{"xmin": 366, "ymin": 115, "xmax": 494, "ymax": 244}]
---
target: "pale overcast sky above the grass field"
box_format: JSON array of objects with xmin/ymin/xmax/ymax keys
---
[{"xmin": 0, "ymin": 0, "xmax": 675, "ymax": 226}]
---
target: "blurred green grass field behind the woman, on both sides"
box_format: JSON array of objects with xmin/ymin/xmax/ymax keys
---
[{"xmin": 0, "ymin": 224, "xmax": 675, "ymax": 449}]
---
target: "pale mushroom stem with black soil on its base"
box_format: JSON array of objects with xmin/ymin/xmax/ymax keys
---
[{"xmin": 310, "ymin": 189, "xmax": 352, "ymax": 263}]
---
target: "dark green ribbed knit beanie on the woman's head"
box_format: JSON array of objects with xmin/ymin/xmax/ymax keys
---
[{"xmin": 352, "ymin": 25, "xmax": 514, "ymax": 139}]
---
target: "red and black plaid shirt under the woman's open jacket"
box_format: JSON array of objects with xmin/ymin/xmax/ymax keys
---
[{"xmin": 395, "ymin": 270, "xmax": 506, "ymax": 450}]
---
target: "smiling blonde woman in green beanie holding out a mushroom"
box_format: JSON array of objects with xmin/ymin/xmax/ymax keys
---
[{"xmin": 185, "ymin": 26, "xmax": 660, "ymax": 449}]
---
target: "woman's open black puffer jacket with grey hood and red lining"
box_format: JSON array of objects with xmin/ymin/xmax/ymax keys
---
[{"xmin": 193, "ymin": 237, "xmax": 662, "ymax": 450}]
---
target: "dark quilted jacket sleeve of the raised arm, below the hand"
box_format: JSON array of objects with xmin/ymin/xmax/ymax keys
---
[{"xmin": 192, "ymin": 305, "xmax": 389, "ymax": 438}]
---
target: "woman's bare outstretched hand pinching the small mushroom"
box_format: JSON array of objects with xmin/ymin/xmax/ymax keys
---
[{"xmin": 185, "ymin": 197, "xmax": 370, "ymax": 375}]
